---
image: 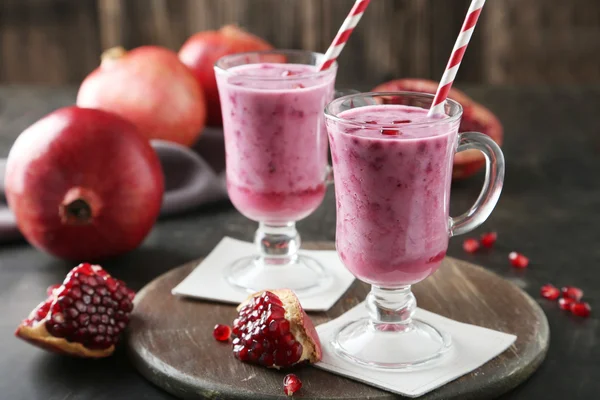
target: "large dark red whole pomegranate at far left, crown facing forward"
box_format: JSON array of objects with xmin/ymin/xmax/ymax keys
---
[{"xmin": 5, "ymin": 106, "xmax": 164, "ymax": 260}]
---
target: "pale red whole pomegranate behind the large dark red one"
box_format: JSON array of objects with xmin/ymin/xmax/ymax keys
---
[{"xmin": 77, "ymin": 46, "xmax": 206, "ymax": 146}]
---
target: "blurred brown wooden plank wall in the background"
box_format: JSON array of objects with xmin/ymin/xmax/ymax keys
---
[{"xmin": 0, "ymin": 0, "xmax": 600, "ymax": 84}]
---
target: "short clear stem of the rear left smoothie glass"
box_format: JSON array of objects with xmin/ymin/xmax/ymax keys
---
[{"xmin": 254, "ymin": 222, "xmax": 300, "ymax": 266}]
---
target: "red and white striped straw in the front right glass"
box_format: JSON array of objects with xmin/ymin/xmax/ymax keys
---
[{"xmin": 428, "ymin": 0, "xmax": 485, "ymax": 116}]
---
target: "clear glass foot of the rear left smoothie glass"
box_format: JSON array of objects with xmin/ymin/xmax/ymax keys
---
[{"xmin": 225, "ymin": 256, "xmax": 333, "ymax": 294}]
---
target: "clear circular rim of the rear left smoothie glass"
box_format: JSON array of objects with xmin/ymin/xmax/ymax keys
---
[{"xmin": 213, "ymin": 49, "xmax": 338, "ymax": 81}]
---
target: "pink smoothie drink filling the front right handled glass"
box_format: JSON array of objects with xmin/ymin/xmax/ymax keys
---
[{"xmin": 327, "ymin": 105, "xmax": 458, "ymax": 288}]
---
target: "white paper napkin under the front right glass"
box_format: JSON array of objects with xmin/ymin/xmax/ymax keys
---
[{"xmin": 315, "ymin": 303, "xmax": 517, "ymax": 397}]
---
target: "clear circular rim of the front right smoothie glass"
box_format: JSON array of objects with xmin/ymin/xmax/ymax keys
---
[{"xmin": 325, "ymin": 91, "xmax": 463, "ymax": 130}]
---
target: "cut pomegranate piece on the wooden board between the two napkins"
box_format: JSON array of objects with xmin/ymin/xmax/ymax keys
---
[{"xmin": 233, "ymin": 289, "xmax": 322, "ymax": 368}]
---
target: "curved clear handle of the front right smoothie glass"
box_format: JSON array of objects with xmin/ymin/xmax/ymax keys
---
[{"xmin": 450, "ymin": 132, "xmax": 504, "ymax": 237}]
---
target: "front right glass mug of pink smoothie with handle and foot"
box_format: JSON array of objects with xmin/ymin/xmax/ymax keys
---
[{"xmin": 325, "ymin": 92, "xmax": 504, "ymax": 369}]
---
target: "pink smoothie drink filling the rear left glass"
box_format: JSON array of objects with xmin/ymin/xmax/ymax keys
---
[{"xmin": 217, "ymin": 63, "xmax": 335, "ymax": 224}]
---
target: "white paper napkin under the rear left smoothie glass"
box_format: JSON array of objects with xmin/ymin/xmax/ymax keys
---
[{"xmin": 172, "ymin": 237, "xmax": 354, "ymax": 311}]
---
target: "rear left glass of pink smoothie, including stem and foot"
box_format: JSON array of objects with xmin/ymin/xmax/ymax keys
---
[{"xmin": 215, "ymin": 50, "xmax": 337, "ymax": 292}]
